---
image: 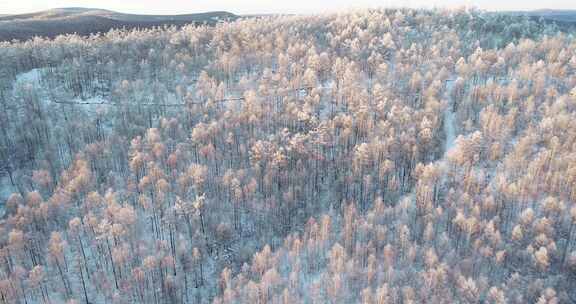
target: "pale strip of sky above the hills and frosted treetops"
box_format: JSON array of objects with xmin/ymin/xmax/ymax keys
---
[{"xmin": 0, "ymin": 0, "xmax": 576, "ymax": 14}]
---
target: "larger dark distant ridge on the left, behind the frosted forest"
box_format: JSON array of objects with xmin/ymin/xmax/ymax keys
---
[{"xmin": 0, "ymin": 7, "xmax": 239, "ymax": 41}]
